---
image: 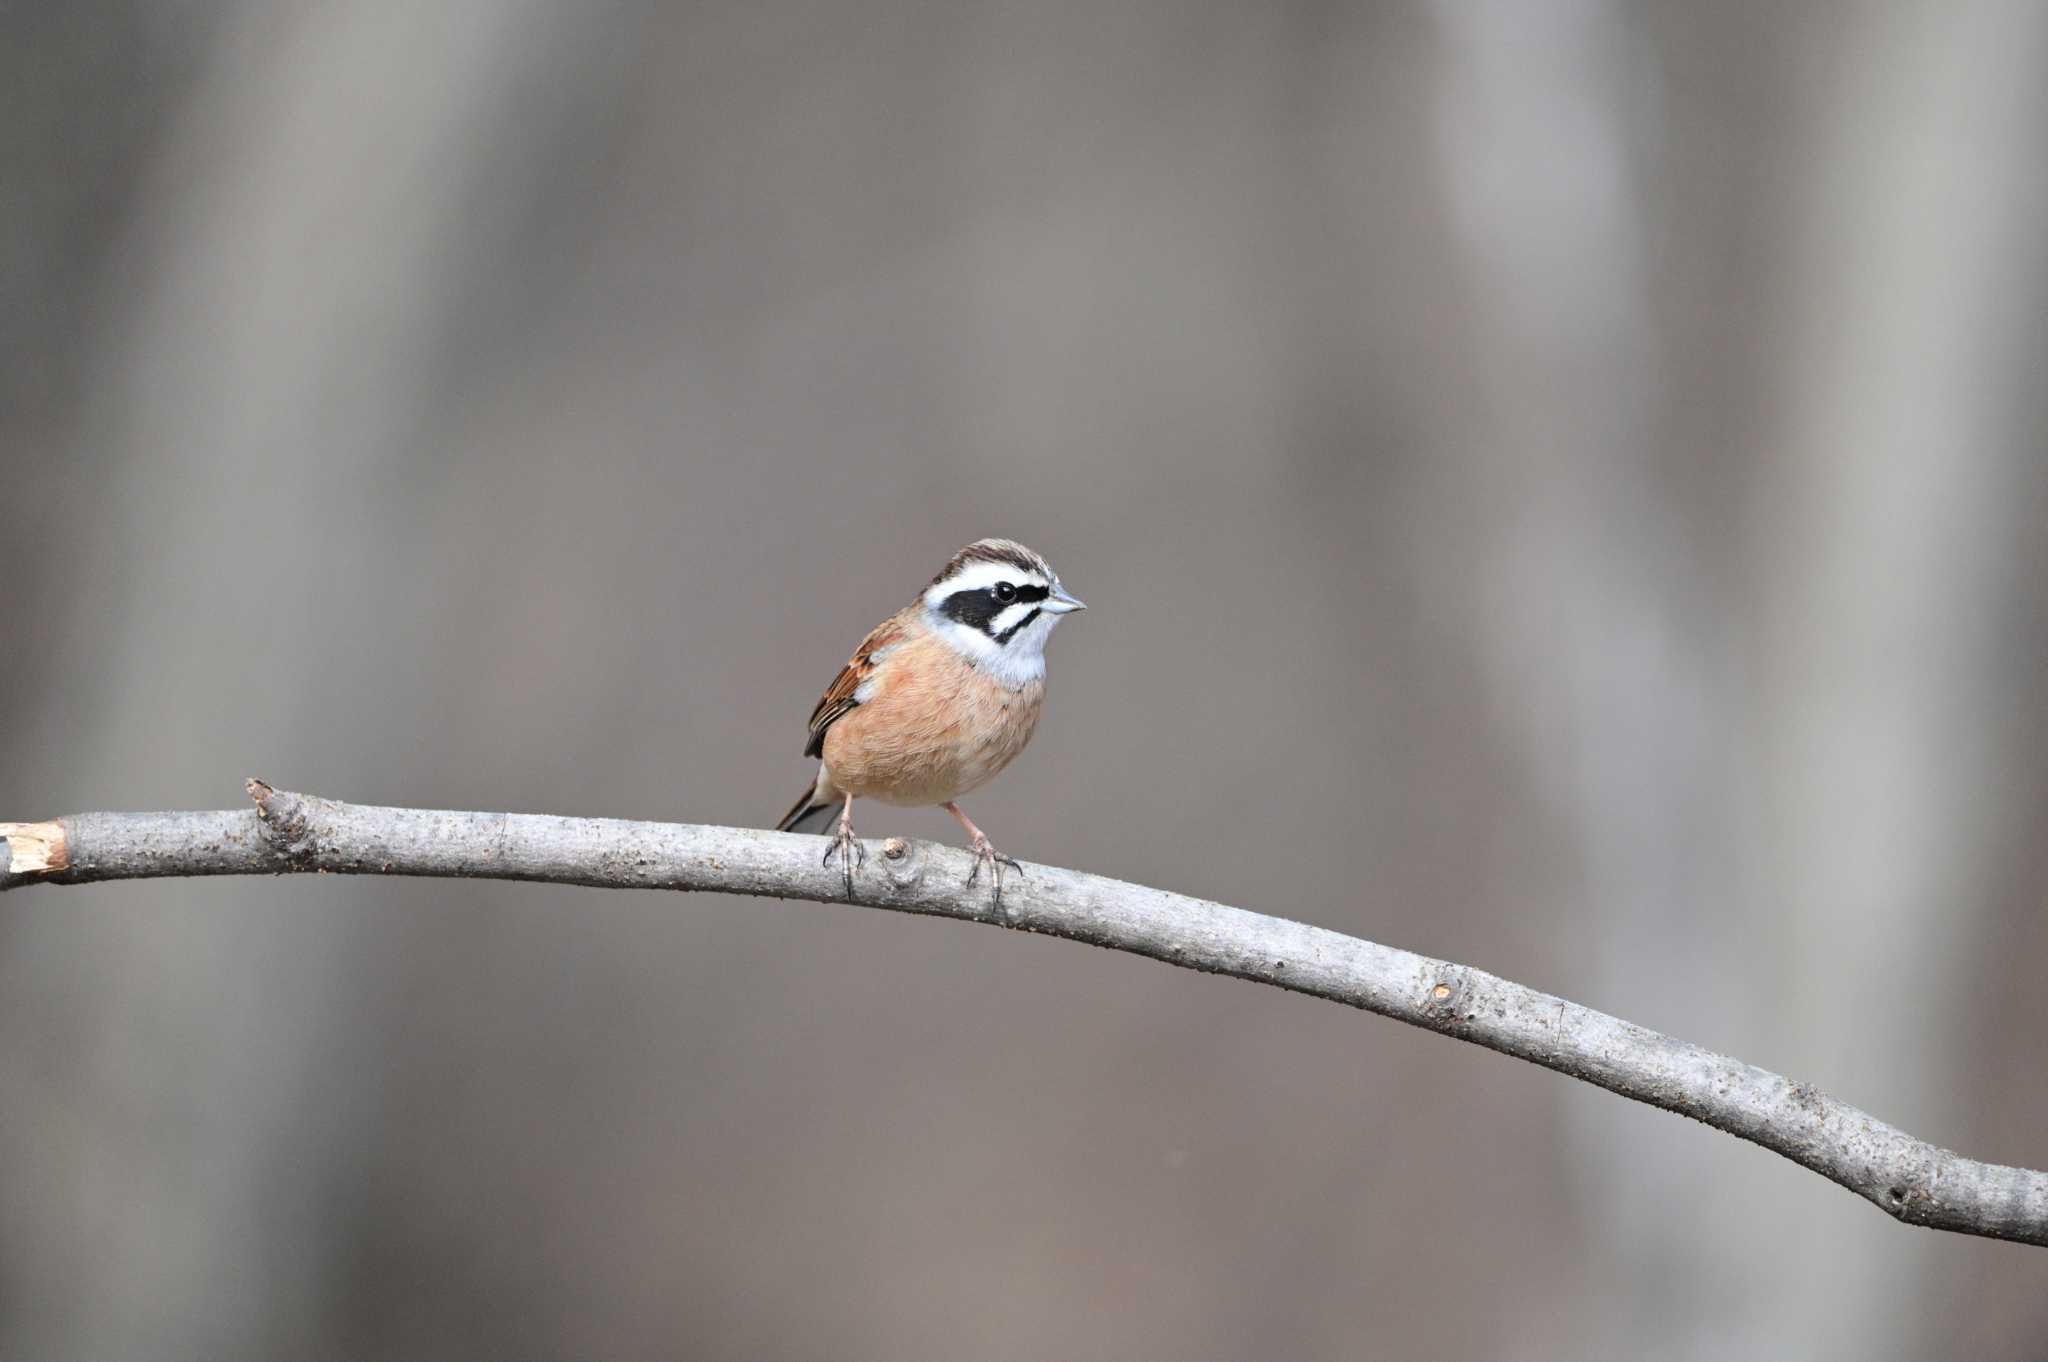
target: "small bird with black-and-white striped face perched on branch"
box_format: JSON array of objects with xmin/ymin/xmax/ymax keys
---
[{"xmin": 776, "ymin": 539, "xmax": 1087, "ymax": 909}]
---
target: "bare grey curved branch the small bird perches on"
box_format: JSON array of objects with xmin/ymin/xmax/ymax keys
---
[{"xmin": 0, "ymin": 780, "xmax": 2048, "ymax": 1245}]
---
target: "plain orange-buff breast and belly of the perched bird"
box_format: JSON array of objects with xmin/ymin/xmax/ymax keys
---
[{"xmin": 823, "ymin": 631, "xmax": 1044, "ymax": 805}]
